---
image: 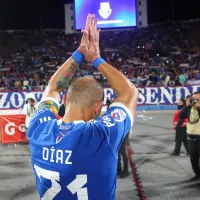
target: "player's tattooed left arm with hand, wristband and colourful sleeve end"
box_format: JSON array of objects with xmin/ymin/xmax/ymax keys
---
[{"xmin": 31, "ymin": 15, "xmax": 95, "ymax": 119}]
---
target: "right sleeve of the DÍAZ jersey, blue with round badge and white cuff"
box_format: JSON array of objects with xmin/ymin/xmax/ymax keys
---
[{"xmin": 97, "ymin": 103, "xmax": 133, "ymax": 156}]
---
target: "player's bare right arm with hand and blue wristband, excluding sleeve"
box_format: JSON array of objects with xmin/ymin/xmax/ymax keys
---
[{"xmin": 82, "ymin": 19, "xmax": 138, "ymax": 116}]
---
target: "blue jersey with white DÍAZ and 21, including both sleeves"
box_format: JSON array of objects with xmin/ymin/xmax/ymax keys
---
[{"xmin": 27, "ymin": 98, "xmax": 133, "ymax": 200}]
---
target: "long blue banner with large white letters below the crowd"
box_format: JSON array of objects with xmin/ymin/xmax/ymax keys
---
[{"xmin": 0, "ymin": 85, "xmax": 200, "ymax": 111}]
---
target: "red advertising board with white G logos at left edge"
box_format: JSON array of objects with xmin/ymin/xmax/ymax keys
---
[{"xmin": 0, "ymin": 115, "xmax": 27, "ymax": 144}]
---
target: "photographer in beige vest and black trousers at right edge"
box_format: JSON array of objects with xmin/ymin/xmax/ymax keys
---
[{"xmin": 179, "ymin": 92, "xmax": 200, "ymax": 181}]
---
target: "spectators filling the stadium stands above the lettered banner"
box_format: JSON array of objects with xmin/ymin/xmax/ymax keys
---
[{"xmin": 0, "ymin": 20, "xmax": 200, "ymax": 91}]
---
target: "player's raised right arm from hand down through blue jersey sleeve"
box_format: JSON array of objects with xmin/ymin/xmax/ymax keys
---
[{"xmin": 79, "ymin": 15, "xmax": 138, "ymax": 156}]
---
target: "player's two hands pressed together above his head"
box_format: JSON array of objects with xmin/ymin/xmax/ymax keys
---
[{"xmin": 78, "ymin": 14, "xmax": 100, "ymax": 63}]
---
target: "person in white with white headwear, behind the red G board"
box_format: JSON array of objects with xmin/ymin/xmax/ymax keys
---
[{"xmin": 22, "ymin": 93, "xmax": 38, "ymax": 129}]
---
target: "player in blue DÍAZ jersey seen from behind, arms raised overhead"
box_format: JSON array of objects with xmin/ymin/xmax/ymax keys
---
[{"xmin": 28, "ymin": 15, "xmax": 138, "ymax": 200}]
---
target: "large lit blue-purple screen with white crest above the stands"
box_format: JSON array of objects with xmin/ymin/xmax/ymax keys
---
[{"xmin": 75, "ymin": 0, "xmax": 136, "ymax": 30}]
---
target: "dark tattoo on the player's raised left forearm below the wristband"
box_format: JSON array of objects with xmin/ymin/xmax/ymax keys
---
[{"xmin": 56, "ymin": 62, "xmax": 78, "ymax": 90}]
